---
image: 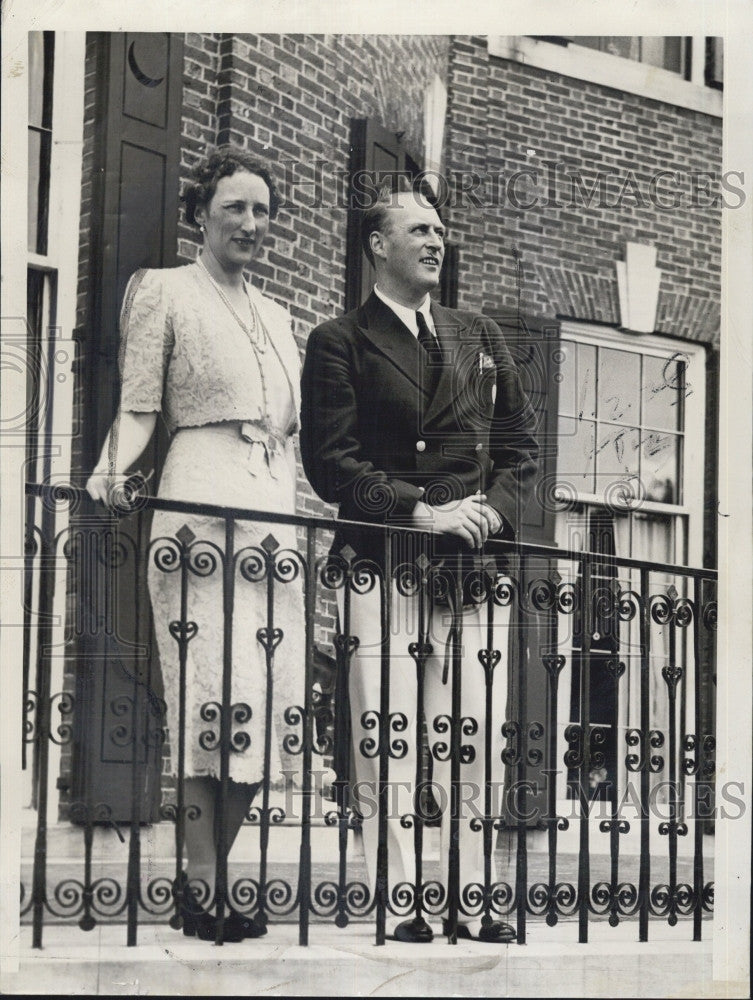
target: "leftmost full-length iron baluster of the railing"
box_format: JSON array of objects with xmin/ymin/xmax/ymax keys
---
[{"xmin": 32, "ymin": 501, "xmax": 55, "ymax": 948}]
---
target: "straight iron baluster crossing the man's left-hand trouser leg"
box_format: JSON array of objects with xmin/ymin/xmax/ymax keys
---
[{"xmin": 376, "ymin": 531, "xmax": 392, "ymax": 945}]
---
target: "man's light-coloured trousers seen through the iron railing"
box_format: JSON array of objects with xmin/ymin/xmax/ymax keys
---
[{"xmin": 339, "ymin": 586, "xmax": 510, "ymax": 916}]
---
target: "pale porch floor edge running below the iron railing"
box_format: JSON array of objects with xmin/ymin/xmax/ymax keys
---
[{"xmin": 2, "ymin": 920, "xmax": 724, "ymax": 998}]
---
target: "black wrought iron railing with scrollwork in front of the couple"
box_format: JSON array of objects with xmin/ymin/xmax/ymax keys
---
[{"xmin": 21, "ymin": 485, "xmax": 716, "ymax": 947}]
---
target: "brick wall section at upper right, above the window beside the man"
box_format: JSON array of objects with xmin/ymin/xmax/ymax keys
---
[{"xmin": 447, "ymin": 38, "xmax": 722, "ymax": 344}]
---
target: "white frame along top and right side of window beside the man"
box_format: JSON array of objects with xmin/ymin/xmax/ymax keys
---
[{"xmin": 560, "ymin": 320, "xmax": 706, "ymax": 566}]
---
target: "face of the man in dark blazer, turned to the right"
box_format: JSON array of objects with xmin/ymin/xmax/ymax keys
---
[{"xmin": 372, "ymin": 192, "xmax": 445, "ymax": 300}]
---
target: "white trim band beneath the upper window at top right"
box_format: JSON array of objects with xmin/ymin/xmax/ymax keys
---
[{"xmin": 489, "ymin": 35, "xmax": 722, "ymax": 118}]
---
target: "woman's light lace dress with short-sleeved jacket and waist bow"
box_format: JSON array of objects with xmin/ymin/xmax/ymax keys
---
[{"xmin": 121, "ymin": 264, "xmax": 304, "ymax": 783}]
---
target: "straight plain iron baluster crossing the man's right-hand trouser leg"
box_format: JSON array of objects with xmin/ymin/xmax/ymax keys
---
[{"xmin": 447, "ymin": 555, "xmax": 463, "ymax": 944}]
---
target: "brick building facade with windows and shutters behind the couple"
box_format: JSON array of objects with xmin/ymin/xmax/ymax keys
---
[{"xmin": 20, "ymin": 32, "xmax": 720, "ymax": 828}]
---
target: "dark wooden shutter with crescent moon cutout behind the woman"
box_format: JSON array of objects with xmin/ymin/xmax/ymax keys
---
[{"xmin": 71, "ymin": 32, "xmax": 183, "ymax": 821}]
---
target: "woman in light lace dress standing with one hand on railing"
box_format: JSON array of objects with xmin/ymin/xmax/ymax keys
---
[{"xmin": 87, "ymin": 146, "xmax": 303, "ymax": 940}]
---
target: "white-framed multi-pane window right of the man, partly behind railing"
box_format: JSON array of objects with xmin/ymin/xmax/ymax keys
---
[{"xmin": 555, "ymin": 323, "xmax": 705, "ymax": 798}]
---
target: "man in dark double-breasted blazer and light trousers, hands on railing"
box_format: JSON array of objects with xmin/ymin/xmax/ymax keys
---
[{"xmin": 301, "ymin": 191, "xmax": 537, "ymax": 942}]
